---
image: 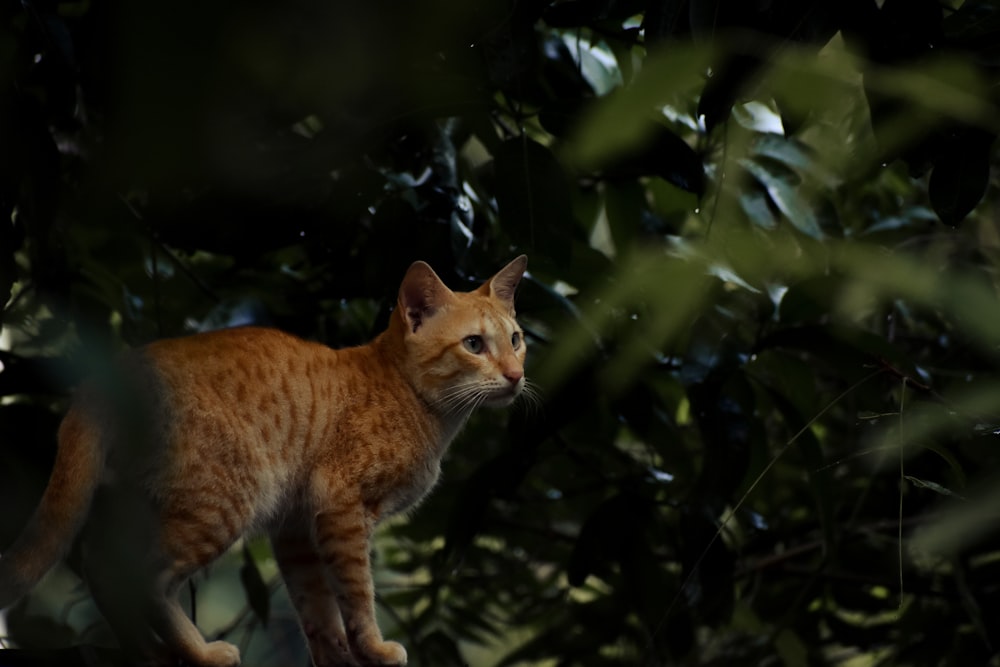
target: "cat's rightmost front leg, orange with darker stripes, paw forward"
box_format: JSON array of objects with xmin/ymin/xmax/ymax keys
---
[{"xmin": 316, "ymin": 502, "xmax": 406, "ymax": 667}]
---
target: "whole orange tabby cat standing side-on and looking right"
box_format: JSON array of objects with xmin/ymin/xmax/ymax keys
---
[{"xmin": 0, "ymin": 255, "xmax": 527, "ymax": 667}]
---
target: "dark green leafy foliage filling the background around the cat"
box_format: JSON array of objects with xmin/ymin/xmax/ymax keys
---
[{"xmin": 0, "ymin": 0, "xmax": 1000, "ymax": 667}]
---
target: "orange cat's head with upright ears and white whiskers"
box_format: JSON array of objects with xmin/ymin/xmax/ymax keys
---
[{"xmin": 393, "ymin": 255, "xmax": 528, "ymax": 415}]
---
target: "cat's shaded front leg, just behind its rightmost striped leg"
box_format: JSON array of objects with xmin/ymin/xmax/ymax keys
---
[{"xmin": 271, "ymin": 523, "xmax": 358, "ymax": 667}]
